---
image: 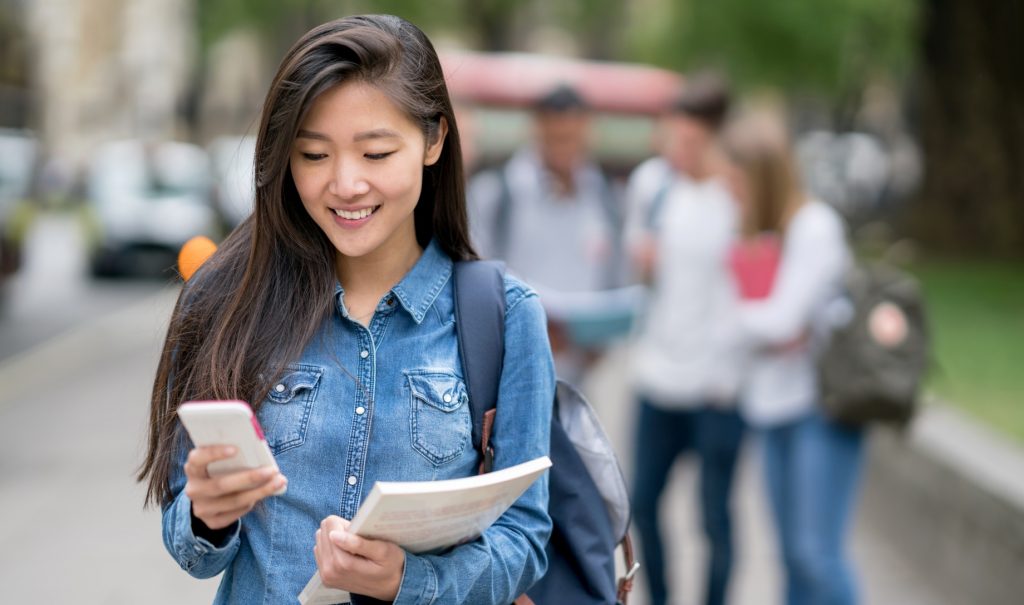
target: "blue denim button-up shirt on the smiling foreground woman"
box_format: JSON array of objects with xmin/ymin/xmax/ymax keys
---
[{"xmin": 163, "ymin": 243, "xmax": 554, "ymax": 605}]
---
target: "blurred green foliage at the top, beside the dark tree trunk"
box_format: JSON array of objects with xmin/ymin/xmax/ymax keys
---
[{"xmin": 627, "ymin": 0, "xmax": 916, "ymax": 94}]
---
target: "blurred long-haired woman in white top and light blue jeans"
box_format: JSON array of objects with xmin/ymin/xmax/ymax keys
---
[{"xmin": 724, "ymin": 114, "xmax": 863, "ymax": 605}]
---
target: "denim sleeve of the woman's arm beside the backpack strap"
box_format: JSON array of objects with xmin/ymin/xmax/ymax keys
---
[{"xmin": 394, "ymin": 280, "xmax": 555, "ymax": 605}]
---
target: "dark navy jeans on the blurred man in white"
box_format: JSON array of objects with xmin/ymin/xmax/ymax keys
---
[{"xmin": 633, "ymin": 398, "xmax": 744, "ymax": 605}]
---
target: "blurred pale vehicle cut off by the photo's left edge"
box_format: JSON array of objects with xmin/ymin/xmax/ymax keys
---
[{"xmin": 0, "ymin": 129, "xmax": 39, "ymax": 284}]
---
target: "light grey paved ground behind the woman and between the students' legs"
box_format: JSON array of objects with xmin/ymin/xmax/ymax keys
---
[{"xmin": 0, "ymin": 214, "xmax": 954, "ymax": 605}]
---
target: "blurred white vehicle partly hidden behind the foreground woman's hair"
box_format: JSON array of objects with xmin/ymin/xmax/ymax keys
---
[{"xmin": 207, "ymin": 135, "xmax": 256, "ymax": 230}]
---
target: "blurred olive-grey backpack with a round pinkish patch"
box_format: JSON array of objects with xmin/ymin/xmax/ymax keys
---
[{"xmin": 818, "ymin": 264, "xmax": 929, "ymax": 426}]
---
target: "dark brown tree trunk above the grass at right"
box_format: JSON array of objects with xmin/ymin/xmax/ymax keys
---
[{"xmin": 911, "ymin": 0, "xmax": 1024, "ymax": 257}]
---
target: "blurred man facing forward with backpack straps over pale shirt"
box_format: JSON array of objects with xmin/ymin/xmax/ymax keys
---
[{"xmin": 468, "ymin": 84, "xmax": 623, "ymax": 382}]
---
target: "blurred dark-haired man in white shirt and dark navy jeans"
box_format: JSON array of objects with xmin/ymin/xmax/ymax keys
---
[{"xmin": 627, "ymin": 75, "xmax": 744, "ymax": 605}]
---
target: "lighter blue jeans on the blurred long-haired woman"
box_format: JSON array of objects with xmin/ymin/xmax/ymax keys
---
[{"xmin": 763, "ymin": 412, "xmax": 864, "ymax": 605}]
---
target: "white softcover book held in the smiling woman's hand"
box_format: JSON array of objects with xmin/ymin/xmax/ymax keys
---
[{"xmin": 299, "ymin": 456, "xmax": 551, "ymax": 605}]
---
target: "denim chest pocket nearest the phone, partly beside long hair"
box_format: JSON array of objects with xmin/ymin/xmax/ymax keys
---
[{"xmin": 259, "ymin": 363, "xmax": 324, "ymax": 455}]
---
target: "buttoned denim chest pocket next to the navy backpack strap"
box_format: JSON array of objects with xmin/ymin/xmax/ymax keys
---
[{"xmin": 404, "ymin": 371, "xmax": 472, "ymax": 465}]
